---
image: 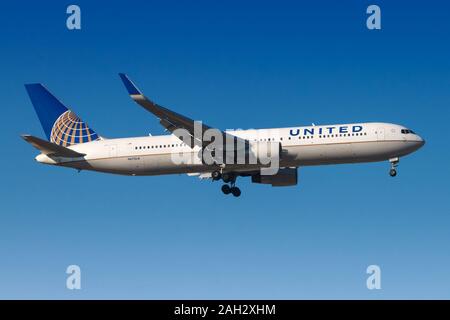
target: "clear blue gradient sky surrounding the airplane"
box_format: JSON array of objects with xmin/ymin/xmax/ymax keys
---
[{"xmin": 0, "ymin": 0, "xmax": 450, "ymax": 299}]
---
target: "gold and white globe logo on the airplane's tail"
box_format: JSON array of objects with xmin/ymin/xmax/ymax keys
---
[{"xmin": 50, "ymin": 110, "xmax": 99, "ymax": 147}]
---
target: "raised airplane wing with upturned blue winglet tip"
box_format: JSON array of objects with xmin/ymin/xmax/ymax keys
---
[{"xmin": 119, "ymin": 73, "xmax": 248, "ymax": 148}]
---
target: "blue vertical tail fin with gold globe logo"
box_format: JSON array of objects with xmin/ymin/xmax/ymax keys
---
[{"xmin": 25, "ymin": 83, "xmax": 99, "ymax": 147}]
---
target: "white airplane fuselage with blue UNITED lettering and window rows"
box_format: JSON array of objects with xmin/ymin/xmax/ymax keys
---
[{"xmin": 36, "ymin": 123, "xmax": 424, "ymax": 175}]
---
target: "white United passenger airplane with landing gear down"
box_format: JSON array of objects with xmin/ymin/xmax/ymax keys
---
[{"xmin": 22, "ymin": 73, "xmax": 425, "ymax": 197}]
